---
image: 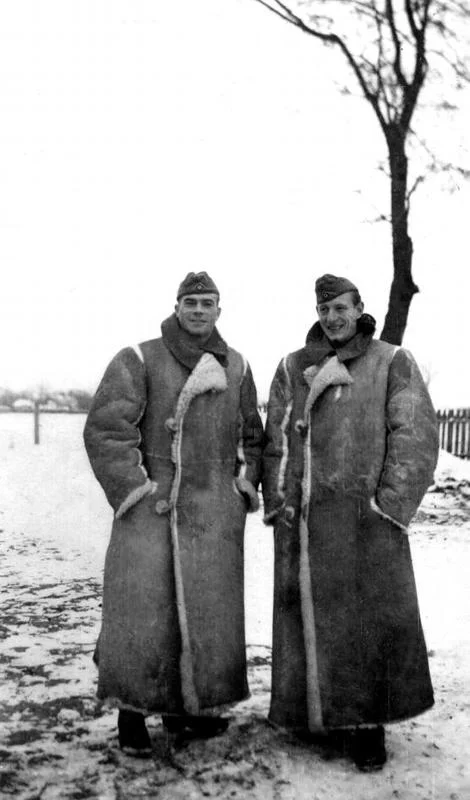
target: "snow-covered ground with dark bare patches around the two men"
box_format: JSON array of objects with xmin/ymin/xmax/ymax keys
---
[{"xmin": 0, "ymin": 414, "xmax": 470, "ymax": 800}]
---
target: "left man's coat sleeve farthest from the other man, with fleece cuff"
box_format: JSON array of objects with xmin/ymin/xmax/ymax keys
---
[{"xmin": 84, "ymin": 347, "xmax": 155, "ymax": 517}]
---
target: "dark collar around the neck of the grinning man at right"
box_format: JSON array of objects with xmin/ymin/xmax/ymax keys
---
[{"xmin": 300, "ymin": 314, "xmax": 375, "ymax": 369}]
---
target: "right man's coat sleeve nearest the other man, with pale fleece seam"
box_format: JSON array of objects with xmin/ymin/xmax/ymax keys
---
[{"xmin": 262, "ymin": 359, "xmax": 292, "ymax": 523}]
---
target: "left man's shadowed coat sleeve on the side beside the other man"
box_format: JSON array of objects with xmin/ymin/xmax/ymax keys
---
[{"xmin": 235, "ymin": 364, "xmax": 264, "ymax": 511}]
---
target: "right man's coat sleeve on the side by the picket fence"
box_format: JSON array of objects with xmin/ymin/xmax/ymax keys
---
[{"xmin": 376, "ymin": 349, "xmax": 439, "ymax": 527}]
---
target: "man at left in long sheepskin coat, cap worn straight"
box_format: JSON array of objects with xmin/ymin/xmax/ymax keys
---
[{"xmin": 84, "ymin": 272, "xmax": 263, "ymax": 755}]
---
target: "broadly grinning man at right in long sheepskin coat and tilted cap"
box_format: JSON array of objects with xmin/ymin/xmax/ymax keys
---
[{"xmin": 263, "ymin": 275, "xmax": 438, "ymax": 770}]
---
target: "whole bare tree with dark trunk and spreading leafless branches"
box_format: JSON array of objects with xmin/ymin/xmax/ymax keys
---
[{"xmin": 255, "ymin": 0, "xmax": 470, "ymax": 344}]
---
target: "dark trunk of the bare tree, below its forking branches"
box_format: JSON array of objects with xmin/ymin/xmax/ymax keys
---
[{"xmin": 380, "ymin": 125, "xmax": 419, "ymax": 345}]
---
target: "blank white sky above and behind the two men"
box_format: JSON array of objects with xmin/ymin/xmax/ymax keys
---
[{"xmin": 0, "ymin": 0, "xmax": 470, "ymax": 407}]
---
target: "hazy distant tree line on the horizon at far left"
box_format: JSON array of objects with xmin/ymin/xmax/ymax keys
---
[{"xmin": 0, "ymin": 388, "xmax": 93, "ymax": 413}]
